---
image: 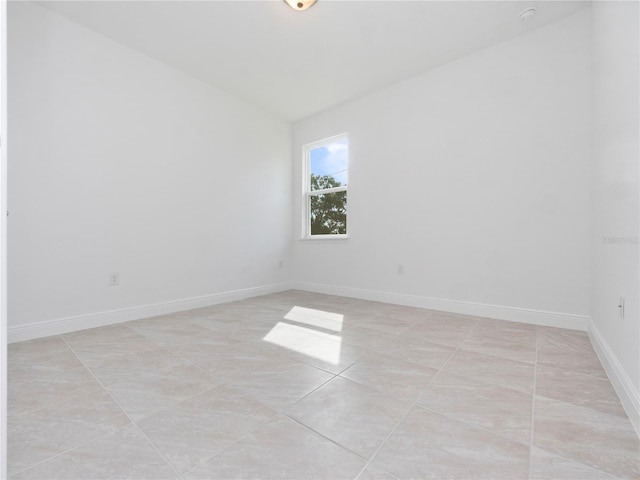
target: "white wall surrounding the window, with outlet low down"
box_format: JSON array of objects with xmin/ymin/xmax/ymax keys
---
[{"xmin": 293, "ymin": 10, "xmax": 591, "ymax": 328}]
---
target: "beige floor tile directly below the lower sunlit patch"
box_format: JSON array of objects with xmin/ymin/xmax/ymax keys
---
[{"xmin": 229, "ymin": 362, "xmax": 333, "ymax": 410}]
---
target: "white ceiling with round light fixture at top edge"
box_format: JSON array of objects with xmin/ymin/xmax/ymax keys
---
[{"xmin": 39, "ymin": 0, "xmax": 589, "ymax": 121}]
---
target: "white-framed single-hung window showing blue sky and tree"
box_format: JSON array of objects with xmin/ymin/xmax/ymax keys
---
[{"xmin": 303, "ymin": 134, "xmax": 349, "ymax": 238}]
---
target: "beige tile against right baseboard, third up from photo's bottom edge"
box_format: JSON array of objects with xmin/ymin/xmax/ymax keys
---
[{"xmin": 536, "ymin": 365, "xmax": 627, "ymax": 418}]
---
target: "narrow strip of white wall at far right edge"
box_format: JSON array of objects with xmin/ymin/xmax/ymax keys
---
[{"xmin": 590, "ymin": 1, "xmax": 640, "ymax": 432}]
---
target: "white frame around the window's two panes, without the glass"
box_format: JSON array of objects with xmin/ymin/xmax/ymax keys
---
[{"xmin": 302, "ymin": 132, "xmax": 350, "ymax": 240}]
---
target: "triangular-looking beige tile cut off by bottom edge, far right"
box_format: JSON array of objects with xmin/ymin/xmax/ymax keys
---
[{"xmin": 530, "ymin": 448, "xmax": 618, "ymax": 480}]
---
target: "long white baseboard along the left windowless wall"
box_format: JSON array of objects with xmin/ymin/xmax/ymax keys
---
[{"xmin": 7, "ymin": 282, "xmax": 291, "ymax": 343}]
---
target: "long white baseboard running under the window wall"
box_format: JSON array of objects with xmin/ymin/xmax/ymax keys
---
[{"xmin": 292, "ymin": 282, "xmax": 589, "ymax": 331}]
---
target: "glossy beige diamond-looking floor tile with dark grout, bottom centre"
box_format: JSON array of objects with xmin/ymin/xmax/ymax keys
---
[{"xmin": 285, "ymin": 377, "xmax": 408, "ymax": 458}]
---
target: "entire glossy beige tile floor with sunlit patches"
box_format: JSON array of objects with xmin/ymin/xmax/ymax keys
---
[{"xmin": 8, "ymin": 291, "xmax": 640, "ymax": 480}]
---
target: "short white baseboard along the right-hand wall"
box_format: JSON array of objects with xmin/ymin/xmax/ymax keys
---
[{"xmin": 588, "ymin": 320, "xmax": 640, "ymax": 437}]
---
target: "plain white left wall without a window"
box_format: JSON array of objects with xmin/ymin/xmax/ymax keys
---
[{"xmin": 8, "ymin": 2, "xmax": 291, "ymax": 338}]
